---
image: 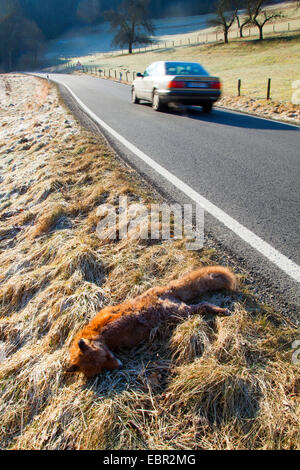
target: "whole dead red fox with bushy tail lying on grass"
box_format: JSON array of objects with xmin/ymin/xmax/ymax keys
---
[{"xmin": 67, "ymin": 266, "xmax": 236, "ymax": 377}]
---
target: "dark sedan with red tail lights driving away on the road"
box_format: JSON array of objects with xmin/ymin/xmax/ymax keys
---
[{"xmin": 131, "ymin": 62, "xmax": 221, "ymax": 113}]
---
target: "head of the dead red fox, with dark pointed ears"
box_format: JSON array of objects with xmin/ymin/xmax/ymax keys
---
[{"xmin": 66, "ymin": 338, "xmax": 122, "ymax": 378}]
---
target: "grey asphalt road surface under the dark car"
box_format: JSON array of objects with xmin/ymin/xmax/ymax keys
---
[{"xmin": 40, "ymin": 75, "xmax": 300, "ymax": 320}]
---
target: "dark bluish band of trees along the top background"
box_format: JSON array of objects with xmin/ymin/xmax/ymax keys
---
[{"xmin": 0, "ymin": 0, "xmax": 294, "ymax": 71}]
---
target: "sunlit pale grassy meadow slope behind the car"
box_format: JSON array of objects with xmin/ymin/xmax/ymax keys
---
[{"xmin": 65, "ymin": 33, "xmax": 300, "ymax": 108}]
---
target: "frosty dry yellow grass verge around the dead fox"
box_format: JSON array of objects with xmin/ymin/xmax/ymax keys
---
[{"xmin": 0, "ymin": 77, "xmax": 300, "ymax": 449}]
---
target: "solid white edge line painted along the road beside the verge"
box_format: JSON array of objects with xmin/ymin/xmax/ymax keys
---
[{"xmin": 51, "ymin": 79, "xmax": 300, "ymax": 282}]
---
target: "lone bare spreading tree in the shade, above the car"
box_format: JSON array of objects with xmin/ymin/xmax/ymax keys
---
[{"xmin": 104, "ymin": 0, "xmax": 154, "ymax": 54}]
